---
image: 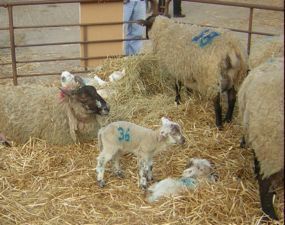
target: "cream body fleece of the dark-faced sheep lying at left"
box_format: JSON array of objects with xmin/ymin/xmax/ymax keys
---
[{"xmin": 0, "ymin": 85, "xmax": 99, "ymax": 145}]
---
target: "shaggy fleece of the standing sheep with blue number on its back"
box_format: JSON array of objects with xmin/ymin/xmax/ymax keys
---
[{"xmin": 150, "ymin": 16, "xmax": 248, "ymax": 98}]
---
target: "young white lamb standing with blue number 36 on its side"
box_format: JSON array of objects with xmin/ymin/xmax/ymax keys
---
[{"xmin": 96, "ymin": 117, "xmax": 185, "ymax": 189}]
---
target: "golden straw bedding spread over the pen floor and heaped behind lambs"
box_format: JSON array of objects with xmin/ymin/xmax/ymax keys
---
[{"xmin": 0, "ymin": 55, "xmax": 284, "ymax": 225}]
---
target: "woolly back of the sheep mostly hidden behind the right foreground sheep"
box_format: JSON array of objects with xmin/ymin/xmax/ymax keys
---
[{"xmin": 249, "ymin": 35, "xmax": 284, "ymax": 69}]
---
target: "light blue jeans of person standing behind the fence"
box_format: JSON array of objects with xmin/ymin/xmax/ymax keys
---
[{"xmin": 124, "ymin": 0, "xmax": 146, "ymax": 55}]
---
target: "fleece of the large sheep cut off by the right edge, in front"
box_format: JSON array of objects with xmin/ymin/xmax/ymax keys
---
[{"xmin": 238, "ymin": 58, "xmax": 284, "ymax": 179}]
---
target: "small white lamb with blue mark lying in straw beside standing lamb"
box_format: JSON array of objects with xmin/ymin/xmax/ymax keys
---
[{"xmin": 147, "ymin": 158, "xmax": 216, "ymax": 202}]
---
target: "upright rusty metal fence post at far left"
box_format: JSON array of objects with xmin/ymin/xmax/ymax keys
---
[{"xmin": 8, "ymin": 5, "xmax": 18, "ymax": 85}]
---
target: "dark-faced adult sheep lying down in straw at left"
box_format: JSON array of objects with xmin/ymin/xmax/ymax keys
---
[{"xmin": 0, "ymin": 85, "xmax": 109, "ymax": 145}]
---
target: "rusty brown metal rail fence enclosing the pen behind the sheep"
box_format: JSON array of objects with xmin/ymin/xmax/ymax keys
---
[{"xmin": 0, "ymin": 0, "xmax": 284, "ymax": 85}]
